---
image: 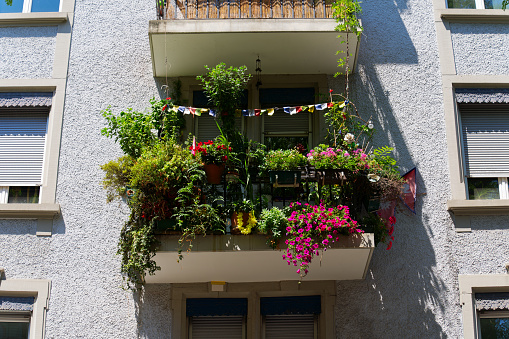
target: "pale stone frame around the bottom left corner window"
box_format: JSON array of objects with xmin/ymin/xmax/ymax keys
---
[{"xmin": 0, "ymin": 279, "xmax": 51, "ymax": 339}]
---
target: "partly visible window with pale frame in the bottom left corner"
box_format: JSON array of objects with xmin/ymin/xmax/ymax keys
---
[{"xmin": 0, "ymin": 279, "xmax": 50, "ymax": 339}]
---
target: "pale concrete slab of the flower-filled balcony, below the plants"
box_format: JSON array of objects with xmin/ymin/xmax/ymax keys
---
[{"xmin": 146, "ymin": 233, "xmax": 374, "ymax": 283}]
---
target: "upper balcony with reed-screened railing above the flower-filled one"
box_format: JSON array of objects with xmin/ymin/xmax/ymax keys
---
[{"xmin": 149, "ymin": 0, "xmax": 359, "ymax": 77}]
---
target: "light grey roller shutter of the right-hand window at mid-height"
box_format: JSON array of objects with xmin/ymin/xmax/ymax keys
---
[{"xmin": 458, "ymin": 104, "xmax": 509, "ymax": 178}]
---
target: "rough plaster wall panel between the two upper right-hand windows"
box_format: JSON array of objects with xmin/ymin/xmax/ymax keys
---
[{"xmin": 450, "ymin": 23, "xmax": 509, "ymax": 75}]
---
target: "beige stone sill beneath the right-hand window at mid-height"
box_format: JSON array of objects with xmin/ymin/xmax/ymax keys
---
[{"xmin": 447, "ymin": 199, "xmax": 509, "ymax": 215}]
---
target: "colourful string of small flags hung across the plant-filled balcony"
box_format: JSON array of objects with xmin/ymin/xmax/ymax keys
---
[{"xmin": 170, "ymin": 102, "xmax": 338, "ymax": 117}]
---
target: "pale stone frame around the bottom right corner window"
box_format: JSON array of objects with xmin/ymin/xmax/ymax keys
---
[{"xmin": 458, "ymin": 274, "xmax": 509, "ymax": 339}]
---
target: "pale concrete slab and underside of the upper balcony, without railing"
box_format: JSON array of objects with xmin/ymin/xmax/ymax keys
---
[{"xmin": 149, "ymin": 19, "xmax": 359, "ymax": 77}]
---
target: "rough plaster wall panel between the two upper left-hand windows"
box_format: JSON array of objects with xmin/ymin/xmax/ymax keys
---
[{"xmin": 0, "ymin": 26, "xmax": 57, "ymax": 79}]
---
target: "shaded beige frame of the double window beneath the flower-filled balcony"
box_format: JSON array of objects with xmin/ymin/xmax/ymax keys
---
[{"xmin": 171, "ymin": 281, "xmax": 336, "ymax": 339}]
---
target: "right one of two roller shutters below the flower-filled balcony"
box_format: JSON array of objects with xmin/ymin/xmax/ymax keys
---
[{"xmin": 265, "ymin": 314, "xmax": 316, "ymax": 339}]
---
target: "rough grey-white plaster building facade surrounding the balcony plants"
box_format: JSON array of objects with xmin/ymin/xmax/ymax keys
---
[{"xmin": 0, "ymin": 0, "xmax": 509, "ymax": 338}]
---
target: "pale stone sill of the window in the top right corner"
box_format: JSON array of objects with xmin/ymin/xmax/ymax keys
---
[{"xmin": 439, "ymin": 9, "xmax": 509, "ymax": 23}]
